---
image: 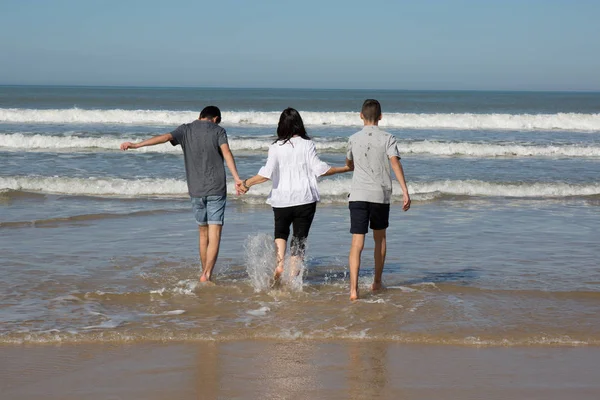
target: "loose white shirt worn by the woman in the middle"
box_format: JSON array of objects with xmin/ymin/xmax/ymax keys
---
[{"xmin": 258, "ymin": 136, "xmax": 330, "ymax": 208}]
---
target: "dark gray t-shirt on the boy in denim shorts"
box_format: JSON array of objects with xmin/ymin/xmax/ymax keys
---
[{"xmin": 171, "ymin": 120, "xmax": 227, "ymax": 197}]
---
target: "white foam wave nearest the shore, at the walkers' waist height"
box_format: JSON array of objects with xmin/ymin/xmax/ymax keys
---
[{"xmin": 0, "ymin": 176, "xmax": 600, "ymax": 203}]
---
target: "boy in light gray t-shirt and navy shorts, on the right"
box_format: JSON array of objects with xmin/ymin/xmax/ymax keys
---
[{"xmin": 346, "ymin": 99, "xmax": 410, "ymax": 300}]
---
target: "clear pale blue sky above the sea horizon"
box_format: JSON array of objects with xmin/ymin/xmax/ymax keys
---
[{"xmin": 0, "ymin": 0, "xmax": 600, "ymax": 91}]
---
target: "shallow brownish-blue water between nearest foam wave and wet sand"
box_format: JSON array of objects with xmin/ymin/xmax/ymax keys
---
[{"xmin": 0, "ymin": 201, "xmax": 600, "ymax": 345}]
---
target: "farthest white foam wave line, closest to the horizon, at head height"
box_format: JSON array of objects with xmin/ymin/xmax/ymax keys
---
[{"xmin": 0, "ymin": 108, "xmax": 600, "ymax": 131}]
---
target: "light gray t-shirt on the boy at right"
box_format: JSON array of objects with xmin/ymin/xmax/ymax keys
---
[{"xmin": 346, "ymin": 125, "xmax": 400, "ymax": 204}]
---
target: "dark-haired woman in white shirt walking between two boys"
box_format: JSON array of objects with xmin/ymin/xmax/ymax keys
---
[{"xmin": 238, "ymin": 108, "xmax": 352, "ymax": 280}]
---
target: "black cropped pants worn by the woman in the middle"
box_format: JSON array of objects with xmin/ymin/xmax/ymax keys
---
[{"xmin": 273, "ymin": 203, "xmax": 317, "ymax": 255}]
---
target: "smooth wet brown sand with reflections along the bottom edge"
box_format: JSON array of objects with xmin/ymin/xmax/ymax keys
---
[{"xmin": 0, "ymin": 341, "xmax": 600, "ymax": 400}]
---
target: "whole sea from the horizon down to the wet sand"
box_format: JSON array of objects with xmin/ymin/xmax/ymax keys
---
[{"xmin": 0, "ymin": 87, "xmax": 600, "ymax": 345}]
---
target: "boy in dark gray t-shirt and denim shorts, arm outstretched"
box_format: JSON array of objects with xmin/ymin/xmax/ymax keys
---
[{"xmin": 121, "ymin": 106, "xmax": 242, "ymax": 282}]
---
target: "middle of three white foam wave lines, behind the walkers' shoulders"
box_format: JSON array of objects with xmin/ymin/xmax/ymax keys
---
[{"xmin": 0, "ymin": 133, "xmax": 600, "ymax": 158}]
